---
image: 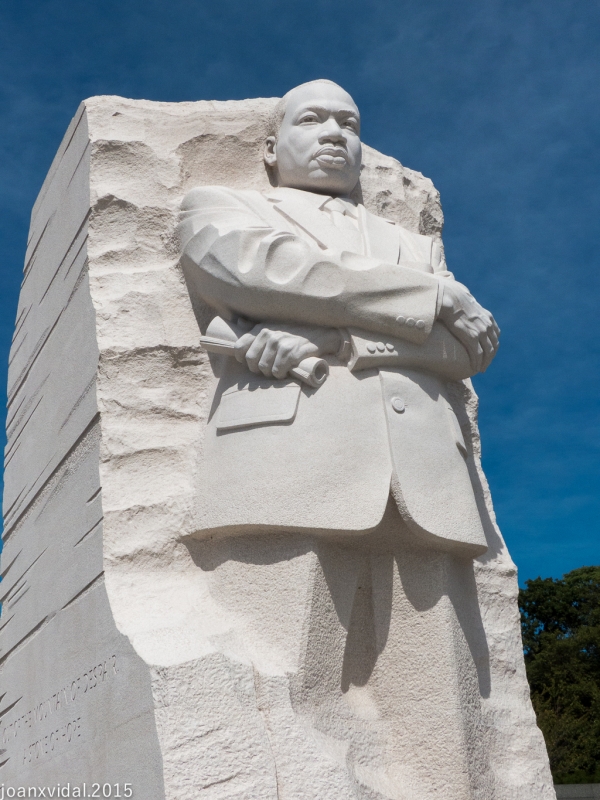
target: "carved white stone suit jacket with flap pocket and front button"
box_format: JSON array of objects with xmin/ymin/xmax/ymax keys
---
[{"xmin": 179, "ymin": 187, "xmax": 486, "ymax": 556}]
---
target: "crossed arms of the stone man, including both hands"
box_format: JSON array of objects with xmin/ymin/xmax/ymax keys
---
[{"xmin": 179, "ymin": 187, "xmax": 499, "ymax": 378}]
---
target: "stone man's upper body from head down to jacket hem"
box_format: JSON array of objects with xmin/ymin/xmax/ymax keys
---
[{"xmin": 179, "ymin": 80, "xmax": 499, "ymax": 558}]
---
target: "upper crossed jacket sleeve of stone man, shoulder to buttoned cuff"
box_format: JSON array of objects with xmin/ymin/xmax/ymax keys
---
[{"xmin": 178, "ymin": 187, "xmax": 439, "ymax": 344}]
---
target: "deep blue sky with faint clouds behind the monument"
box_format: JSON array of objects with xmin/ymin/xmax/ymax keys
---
[{"xmin": 0, "ymin": 0, "xmax": 600, "ymax": 582}]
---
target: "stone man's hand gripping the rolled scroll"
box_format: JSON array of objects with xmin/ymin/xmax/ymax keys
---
[{"xmin": 235, "ymin": 323, "xmax": 341, "ymax": 379}]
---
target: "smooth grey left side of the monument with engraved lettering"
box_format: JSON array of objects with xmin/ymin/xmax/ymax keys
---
[{"xmin": 0, "ymin": 108, "xmax": 164, "ymax": 800}]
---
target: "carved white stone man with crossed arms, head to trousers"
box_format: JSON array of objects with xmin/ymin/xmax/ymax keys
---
[{"xmin": 171, "ymin": 81, "xmax": 512, "ymax": 800}]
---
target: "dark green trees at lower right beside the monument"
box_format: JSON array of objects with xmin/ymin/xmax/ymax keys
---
[{"xmin": 519, "ymin": 567, "xmax": 600, "ymax": 783}]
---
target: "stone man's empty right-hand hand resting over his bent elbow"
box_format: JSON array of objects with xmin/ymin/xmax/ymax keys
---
[{"xmin": 439, "ymin": 280, "xmax": 500, "ymax": 372}]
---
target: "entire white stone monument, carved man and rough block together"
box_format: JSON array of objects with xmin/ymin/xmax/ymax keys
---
[{"xmin": 0, "ymin": 81, "xmax": 555, "ymax": 800}]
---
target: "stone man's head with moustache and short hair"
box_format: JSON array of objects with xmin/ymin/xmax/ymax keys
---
[{"xmin": 265, "ymin": 80, "xmax": 361, "ymax": 195}]
